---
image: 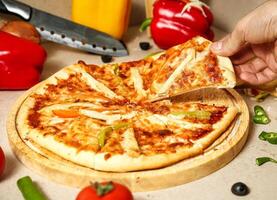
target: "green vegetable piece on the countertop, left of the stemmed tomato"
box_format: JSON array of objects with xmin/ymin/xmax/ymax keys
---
[{"xmin": 17, "ymin": 176, "xmax": 47, "ymax": 200}]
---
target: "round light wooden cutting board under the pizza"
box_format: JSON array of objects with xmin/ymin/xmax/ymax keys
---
[{"xmin": 7, "ymin": 87, "xmax": 249, "ymax": 191}]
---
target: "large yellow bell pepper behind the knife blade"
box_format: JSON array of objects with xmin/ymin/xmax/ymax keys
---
[{"xmin": 72, "ymin": 0, "xmax": 131, "ymax": 39}]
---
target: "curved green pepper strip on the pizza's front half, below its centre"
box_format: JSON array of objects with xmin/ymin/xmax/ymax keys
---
[{"xmin": 97, "ymin": 123, "xmax": 131, "ymax": 148}]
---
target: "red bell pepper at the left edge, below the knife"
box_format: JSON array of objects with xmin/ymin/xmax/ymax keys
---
[{"xmin": 0, "ymin": 31, "xmax": 46, "ymax": 90}]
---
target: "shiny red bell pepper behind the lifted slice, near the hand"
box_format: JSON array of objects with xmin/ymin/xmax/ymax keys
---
[{"xmin": 141, "ymin": 0, "xmax": 214, "ymax": 49}]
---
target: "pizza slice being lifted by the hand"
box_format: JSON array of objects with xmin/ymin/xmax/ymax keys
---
[{"xmin": 148, "ymin": 37, "xmax": 236, "ymax": 99}]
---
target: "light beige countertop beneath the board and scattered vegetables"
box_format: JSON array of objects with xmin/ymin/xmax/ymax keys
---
[{"xmin": 0, "ymin": 28, "xmax": 277, "ymax": 200}]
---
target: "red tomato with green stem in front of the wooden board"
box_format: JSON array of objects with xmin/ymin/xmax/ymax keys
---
[{"xmin": 76, "ymin": 182, "xmax": 133, "ymax": 200}]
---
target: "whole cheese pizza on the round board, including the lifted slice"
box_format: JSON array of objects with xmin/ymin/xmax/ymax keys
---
[{"xmin": 16, "ymin": 38, "xmax": 238, "ymax": 172}]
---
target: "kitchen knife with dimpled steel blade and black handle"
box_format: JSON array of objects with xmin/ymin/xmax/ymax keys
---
[{"xmin": 0, "ymin": 0, "xmax": 128, "ymax": 56}]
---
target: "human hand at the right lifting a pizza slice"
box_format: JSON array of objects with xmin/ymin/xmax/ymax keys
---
[{"xmin": 211, "ymin": 0, "xmax": 277, "ymax": 85}]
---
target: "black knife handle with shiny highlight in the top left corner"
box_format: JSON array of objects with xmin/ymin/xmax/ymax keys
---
[{"xmin": 0, "ymin": 0, "xmax": 32, "ymax": 21}]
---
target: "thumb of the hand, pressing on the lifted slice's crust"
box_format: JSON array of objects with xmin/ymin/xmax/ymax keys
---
[{"xmin": 211, "ymin": 26, "xmax": 246, "ymax": 56}]
